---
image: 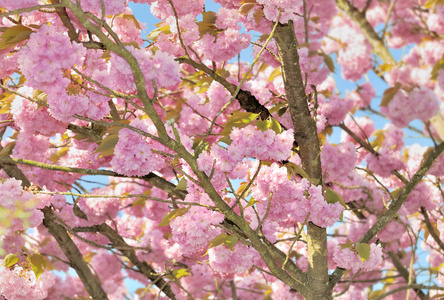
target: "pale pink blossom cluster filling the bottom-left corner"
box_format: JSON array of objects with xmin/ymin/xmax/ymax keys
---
[{"xmin": 0, "ymin": 259, "xmax": 56, "ymax": 300}]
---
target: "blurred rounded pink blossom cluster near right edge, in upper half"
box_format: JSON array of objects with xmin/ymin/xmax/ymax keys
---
[{"xmin": 381, "ymin": 88, "xmax": 439, "ymax": 127}]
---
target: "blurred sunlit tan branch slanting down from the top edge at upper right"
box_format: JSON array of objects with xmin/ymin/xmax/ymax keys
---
[{"xmin": 336, "ymin": 0, "xmax": 396, "ymax": 64}]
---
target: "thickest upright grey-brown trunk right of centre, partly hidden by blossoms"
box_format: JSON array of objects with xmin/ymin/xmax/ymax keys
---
[{"xmin": 275, "ymin": 21, "xmax": 326, "ymax": 299}]
